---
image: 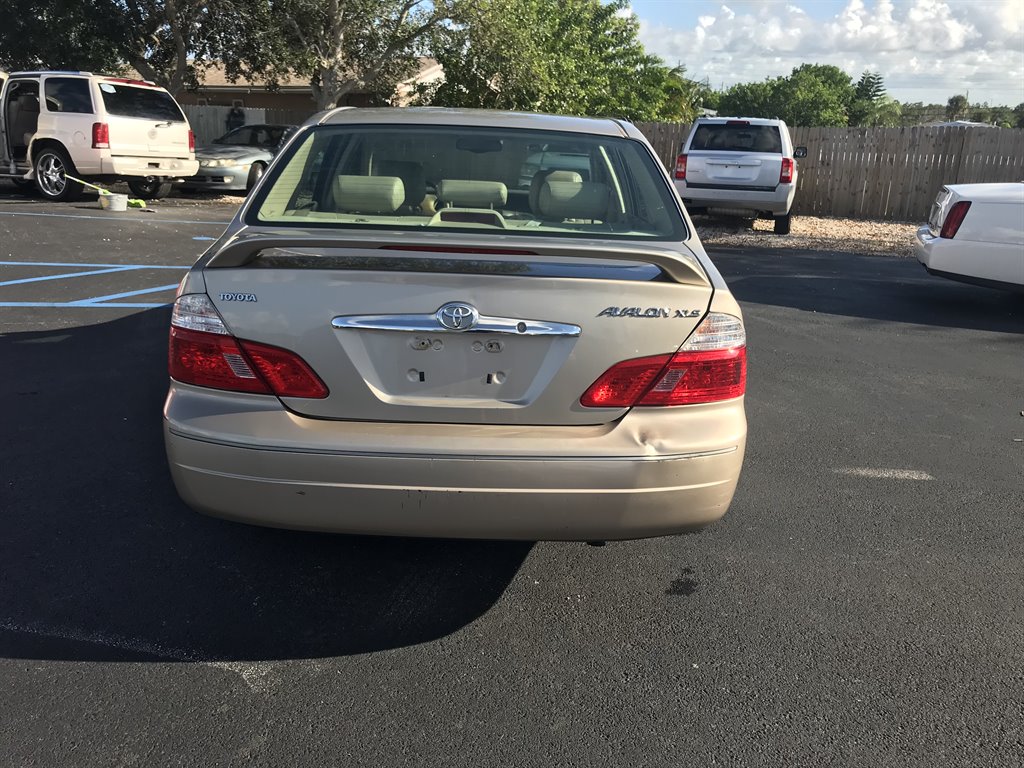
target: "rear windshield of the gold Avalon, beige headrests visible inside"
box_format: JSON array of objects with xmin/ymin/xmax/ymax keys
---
[{"xmin": 247, "ymin": 125, "xmax": 686, "ymax": 241}]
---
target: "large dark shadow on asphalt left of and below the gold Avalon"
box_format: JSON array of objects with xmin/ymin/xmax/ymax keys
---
[{"xmin": 0, "ymin": 309, "xmax": 531, "ymax": 662}]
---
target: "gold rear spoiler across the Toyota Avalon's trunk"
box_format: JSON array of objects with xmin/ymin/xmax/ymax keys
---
[{"xmin": 197, "ymin": 230, "xmax": 712, "ymax": 286}]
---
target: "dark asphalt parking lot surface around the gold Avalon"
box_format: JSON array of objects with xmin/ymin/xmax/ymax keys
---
[{"xmin": 0, "ymin": 188, "xmax": 1024, "ymax": 767}]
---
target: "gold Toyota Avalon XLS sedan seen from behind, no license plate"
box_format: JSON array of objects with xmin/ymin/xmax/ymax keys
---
[{"xmin": 164, "ymin": 108, "xmax": 746, "ymax": 540}]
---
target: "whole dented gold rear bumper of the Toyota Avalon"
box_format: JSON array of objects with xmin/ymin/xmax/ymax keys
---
[{"xmin": 165, "ymin": 384, "xmax": 746, "ymax": 540}]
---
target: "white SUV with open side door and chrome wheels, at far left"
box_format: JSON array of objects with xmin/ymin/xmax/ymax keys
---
[{"xmin": 0, "ymin": 72, "xmax": 199, "ymax": 201}]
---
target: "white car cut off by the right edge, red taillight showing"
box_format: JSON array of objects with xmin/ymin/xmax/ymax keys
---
[{"xmin": 916, "ymin": 181, "xmax": 1024, "ymax": 290}]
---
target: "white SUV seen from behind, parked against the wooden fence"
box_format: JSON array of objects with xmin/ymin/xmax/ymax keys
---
[{"xmin": 675, "ymin": 118, "xmax": 807, "ymax": 234}]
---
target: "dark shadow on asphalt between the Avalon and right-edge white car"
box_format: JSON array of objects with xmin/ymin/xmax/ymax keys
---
[{"xmin": 709, "ymin": 248, "xmax": 1024, "ymax": 334}]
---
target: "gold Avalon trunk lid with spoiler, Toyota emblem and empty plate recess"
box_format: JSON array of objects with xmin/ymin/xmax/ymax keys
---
[{"xmin": 204, "ymin": 237, "xmax": 712, "ymax": 426}]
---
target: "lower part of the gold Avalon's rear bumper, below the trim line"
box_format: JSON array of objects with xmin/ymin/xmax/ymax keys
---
[{"xmin": 165, "ymin": 429, "xmax": 743, "ymax": 540}]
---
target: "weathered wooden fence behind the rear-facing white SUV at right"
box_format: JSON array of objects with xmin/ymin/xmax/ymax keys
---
[{"xmin": 637, "ymin": 123, "xmax": 1024, "ymax": 221}]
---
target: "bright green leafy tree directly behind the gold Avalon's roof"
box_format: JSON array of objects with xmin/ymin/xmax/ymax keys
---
[{"xmin": 419, "ymin": 0, "xmax": 700, "ymax": 121}]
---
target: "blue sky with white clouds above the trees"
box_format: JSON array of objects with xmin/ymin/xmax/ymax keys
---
[{"xmin": 631, "ymin": 0, "xmax": 1024, "ymax": 106}]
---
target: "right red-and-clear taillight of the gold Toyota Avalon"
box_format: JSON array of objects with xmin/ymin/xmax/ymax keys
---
[{"xmin": 580, "ymin": 312, "xmax": 746, "ymax": 408}]
